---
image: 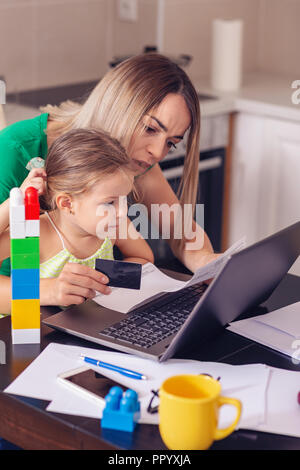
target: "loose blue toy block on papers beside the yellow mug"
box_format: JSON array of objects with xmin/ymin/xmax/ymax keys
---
[{"xmin": 101, "ymin": 387, "xmax": 140, "ymax": 432}]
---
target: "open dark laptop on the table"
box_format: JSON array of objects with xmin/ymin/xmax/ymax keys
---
[{"xmin": 43, "ymin": 222, "xmax": 300, "ymax": 362}]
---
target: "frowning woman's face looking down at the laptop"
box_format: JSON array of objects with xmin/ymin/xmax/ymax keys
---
[{"xmin": 128, "ymin": 93, "xmax": 191, "ymax": 174}]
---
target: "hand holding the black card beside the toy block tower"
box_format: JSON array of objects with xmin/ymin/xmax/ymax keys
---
[{"xmin": 41, "ymin": 263, "xmax": 111, "ymax": 307}]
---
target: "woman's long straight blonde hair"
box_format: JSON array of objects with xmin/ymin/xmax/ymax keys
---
[{"xmin": 42, "ymin": 53, "xmax": 200, "ymax": 246}]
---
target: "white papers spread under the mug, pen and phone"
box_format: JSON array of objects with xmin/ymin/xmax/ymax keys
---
[{"xmin": 5, "ymin": 343, "xmax": 300, "ymax": 437}]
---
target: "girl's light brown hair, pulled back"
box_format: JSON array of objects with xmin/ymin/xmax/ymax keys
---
[{"xmin": 42, "ymin": 129, "xmax": 130, "ymax": 210}]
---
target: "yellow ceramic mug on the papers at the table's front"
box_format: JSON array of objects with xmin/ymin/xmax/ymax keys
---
[{"xmin": 158, "ymin": 375, "xmax": 242, "ymax": 450}]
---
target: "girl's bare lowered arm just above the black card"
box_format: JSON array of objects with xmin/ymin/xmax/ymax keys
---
[{"xmin": 116, "ymin": 218, "xmax": 154, "ymax": 264}]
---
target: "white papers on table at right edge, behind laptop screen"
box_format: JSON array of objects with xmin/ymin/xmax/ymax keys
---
[{"xmin": 227, "ymin": 302, "xmax": 300, "ymax": 358}]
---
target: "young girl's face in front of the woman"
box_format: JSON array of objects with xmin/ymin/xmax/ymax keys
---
[{"xmin": 72, "ymin": 170, "xmax": 133, "ymax": 239}]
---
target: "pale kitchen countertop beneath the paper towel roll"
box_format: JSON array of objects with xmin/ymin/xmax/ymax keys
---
[{"xmin": 194, "ymin": 73, "xmax": 300, "ymax": 122}]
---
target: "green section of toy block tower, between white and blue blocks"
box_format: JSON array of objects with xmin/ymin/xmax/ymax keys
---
[{"xmin": 10, "ymin": 237, "xmax": 40, "ymax": 269}]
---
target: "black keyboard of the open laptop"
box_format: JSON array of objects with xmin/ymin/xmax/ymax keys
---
[{"xmin": 100, "ymin": 284, "xmax": 207, "ymax": 349}]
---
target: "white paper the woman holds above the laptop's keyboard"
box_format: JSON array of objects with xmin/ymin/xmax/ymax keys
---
[{"xmin": 93, "ymin": 238, "xmax": 245, "ymax": 313}]
